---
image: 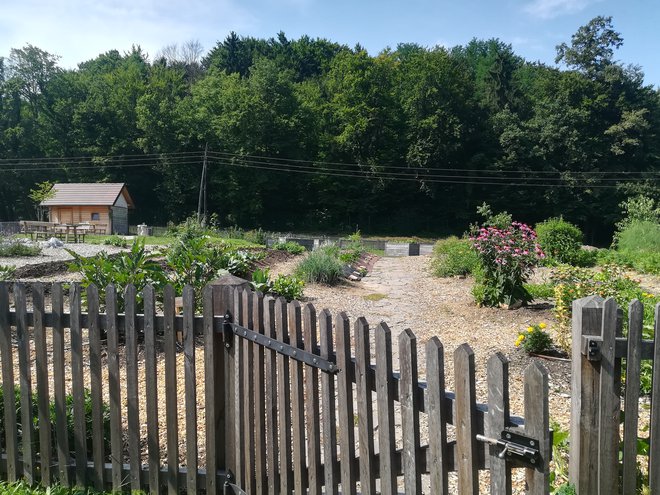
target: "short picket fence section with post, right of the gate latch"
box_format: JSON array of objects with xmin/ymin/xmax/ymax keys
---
[{"xmin": 569, "ymin": 296, "xmax": 660, "ymax": 495}]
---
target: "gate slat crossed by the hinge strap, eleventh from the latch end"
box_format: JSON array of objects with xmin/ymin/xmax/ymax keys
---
[{"xmin": 288, "ymin": 301, "xmax": 307, "ymax": 493}]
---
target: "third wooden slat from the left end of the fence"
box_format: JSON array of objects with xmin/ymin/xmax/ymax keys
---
[{"xmin": 33, "ymin": 282, "xmax": 52, "ymax": 486}]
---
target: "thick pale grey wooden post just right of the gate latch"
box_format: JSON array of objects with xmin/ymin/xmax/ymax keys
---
[{"xmin": 569, "ymin": 296, "xmax": 603, "ymax": 495}]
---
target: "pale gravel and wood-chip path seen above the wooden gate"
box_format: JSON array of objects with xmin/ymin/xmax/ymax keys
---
[{"xmin": 271, "ymin": 256, "xmax": 570, "ymax": 434}]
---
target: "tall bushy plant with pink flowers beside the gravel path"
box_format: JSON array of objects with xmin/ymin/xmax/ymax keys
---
[{"xmin": 470, "ymin": 222, "xmax": 545, "ymax": 306}]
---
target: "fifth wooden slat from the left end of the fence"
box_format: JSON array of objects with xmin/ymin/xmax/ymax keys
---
[{"xmin": 69, "ymin": 283, "xmax": 87, "ymax": 486}]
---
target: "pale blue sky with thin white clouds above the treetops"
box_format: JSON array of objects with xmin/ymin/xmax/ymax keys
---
[{"xmin": 0, "ymin": 0, "xmax": 660, "ymax": 87}]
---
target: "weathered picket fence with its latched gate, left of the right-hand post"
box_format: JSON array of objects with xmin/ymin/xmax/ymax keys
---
[{"xmin": 0, "ymin": 283, "xmax": 551, "ymax": 494}]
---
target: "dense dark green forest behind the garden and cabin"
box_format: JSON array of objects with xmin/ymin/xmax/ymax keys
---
[{"xmin": 0, "ymin": 17, "xmax": 660, "ymax": 244}]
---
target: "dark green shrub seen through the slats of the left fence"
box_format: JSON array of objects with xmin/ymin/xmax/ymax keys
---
[{"xmin": 0, "ymin": 386, "xmax": 110, "ymax": 457}]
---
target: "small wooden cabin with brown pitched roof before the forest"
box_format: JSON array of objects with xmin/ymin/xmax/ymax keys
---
[{"xmin": 41, "ymin": 183, "xmax": 135, "ymax": 235}]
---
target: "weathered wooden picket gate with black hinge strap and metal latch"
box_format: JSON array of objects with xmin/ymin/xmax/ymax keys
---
[{"xmin": 215, "ymin": 284, "xmax": 551, "ymax": 494}]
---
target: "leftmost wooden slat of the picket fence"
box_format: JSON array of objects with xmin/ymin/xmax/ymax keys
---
[{"xmin": 0, "ymin": 282, "xmax": 18, "ymax": 483}]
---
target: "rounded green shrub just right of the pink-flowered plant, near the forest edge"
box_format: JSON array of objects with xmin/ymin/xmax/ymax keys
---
[{"xmin": 536, "ymin": 217, "xmax": 583, "ymax": 265}]
